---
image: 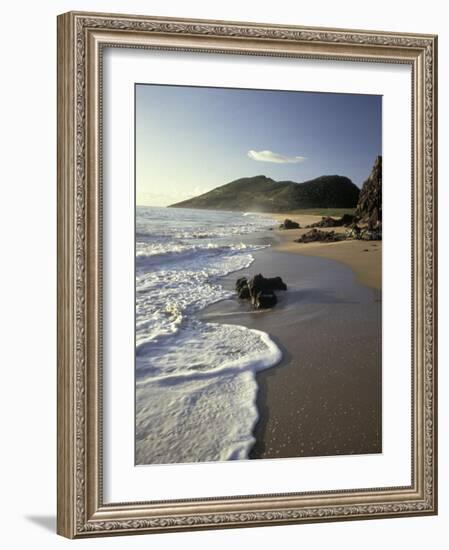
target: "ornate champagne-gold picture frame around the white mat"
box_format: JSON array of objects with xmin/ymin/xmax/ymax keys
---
[{"xmin": 57, "ymin": 12, "xmax": 437, "ymax": 538}]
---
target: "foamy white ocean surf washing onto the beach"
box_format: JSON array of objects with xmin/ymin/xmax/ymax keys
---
[{"xmin": 135, "ymin": 206, "xmax": 281, "ymax": 465}]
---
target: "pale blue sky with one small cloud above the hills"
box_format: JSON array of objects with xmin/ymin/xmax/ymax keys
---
[{"xmin": 135, "ymin": 84, "xmax": 382, "ymax": 206}]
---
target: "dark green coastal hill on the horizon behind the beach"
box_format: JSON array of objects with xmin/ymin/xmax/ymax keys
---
[{"xmin": 170, "ymin": 176, "xmax": 360, "ymax": 212}]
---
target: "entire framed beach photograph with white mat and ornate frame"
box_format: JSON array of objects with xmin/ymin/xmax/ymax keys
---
[{"xmin": 58, "ymin": 12, "xmax": 437, "ymax": 538}]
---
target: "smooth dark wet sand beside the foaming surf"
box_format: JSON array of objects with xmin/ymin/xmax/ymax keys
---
[{"xmin": 202, "ymin": 246, "xmax": 382, "ymax": 458}]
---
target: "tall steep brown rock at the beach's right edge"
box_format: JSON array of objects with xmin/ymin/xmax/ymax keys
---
[{"xmin": 355, "ymin": 156, "xmax": 382, "ymax": 230}]
